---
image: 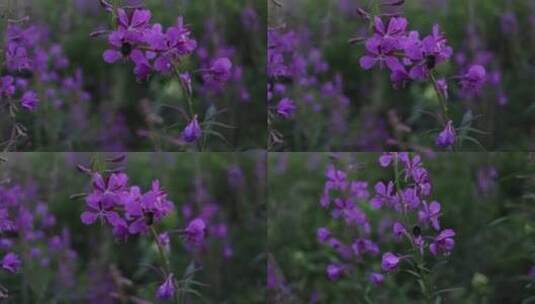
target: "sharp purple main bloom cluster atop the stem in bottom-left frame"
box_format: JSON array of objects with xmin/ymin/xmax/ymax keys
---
[{"xmin": 80, "ymin": 173, "xmax": 174, "ymax": 240}]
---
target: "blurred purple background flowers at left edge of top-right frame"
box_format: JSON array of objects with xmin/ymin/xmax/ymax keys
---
[{"xmin": 267, "ymin": 28, "xmax": 356, "ymax": 148}]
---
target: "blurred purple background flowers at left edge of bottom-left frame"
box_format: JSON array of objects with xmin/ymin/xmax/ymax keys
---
[{"xmin": 0, "ymin": 182, "xmax": 77, "ymax": 288}]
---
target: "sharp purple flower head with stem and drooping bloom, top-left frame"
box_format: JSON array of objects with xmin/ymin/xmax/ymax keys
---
[{"xmin": 95, "ymin": 0, "xmax": 236, "ymax": 144}]
